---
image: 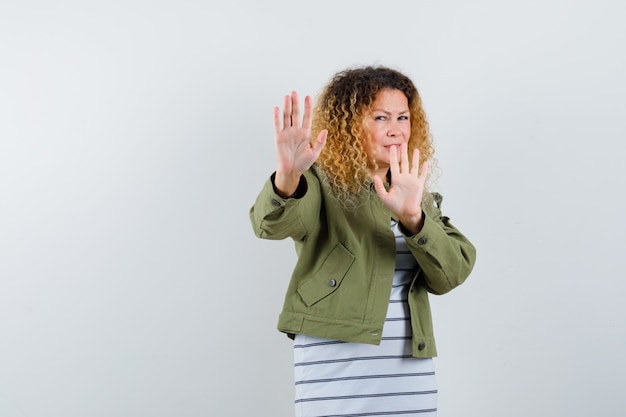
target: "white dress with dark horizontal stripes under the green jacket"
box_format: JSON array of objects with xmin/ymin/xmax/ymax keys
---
[{"xmin": 294, "ymin": 219, "xmax": 437, "ymax": 417}]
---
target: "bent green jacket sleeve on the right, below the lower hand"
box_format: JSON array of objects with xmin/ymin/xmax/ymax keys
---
[{"xmin": 400, "ymin": 194, "xmax": 476, "ymax": 294}]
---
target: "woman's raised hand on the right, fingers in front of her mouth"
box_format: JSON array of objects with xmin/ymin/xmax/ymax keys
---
[{"xmin": 374, "ymin": 143, "xmax": 428, "ymax": 234}]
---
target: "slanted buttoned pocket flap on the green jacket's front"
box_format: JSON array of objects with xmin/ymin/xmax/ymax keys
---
[{"xmin": 298, "ymin": 243, "xmax": 354, "ymax": 307}]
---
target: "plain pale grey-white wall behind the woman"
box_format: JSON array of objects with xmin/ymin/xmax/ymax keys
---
[{"xmin": 0, "ymin": 0, "xmax": 626, "ymax": 417}]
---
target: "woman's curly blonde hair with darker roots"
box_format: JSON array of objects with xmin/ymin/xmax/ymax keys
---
[{"xmin": 311, "ymin": 66, "xmax": 435, "ymax": 207}]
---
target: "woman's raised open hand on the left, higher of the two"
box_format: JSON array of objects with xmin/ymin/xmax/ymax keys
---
[{"xmin": 274, "ymin": 91, "xmax": 328, "ymax": 197}]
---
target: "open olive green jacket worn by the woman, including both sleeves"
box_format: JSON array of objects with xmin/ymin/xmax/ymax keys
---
[{"xmin": 250, "ymin": 167, "xmax": 476, "ymax": 357}]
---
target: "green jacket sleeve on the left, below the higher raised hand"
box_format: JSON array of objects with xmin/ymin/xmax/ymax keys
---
[{"xmin": 250, "ymin": 173, "xmax": 319, "ymax": 240}]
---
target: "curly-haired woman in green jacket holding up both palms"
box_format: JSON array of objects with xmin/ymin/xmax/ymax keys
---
[{"xmin": 250, "ymin": 67, "xmax": 476, "ymax": 417}]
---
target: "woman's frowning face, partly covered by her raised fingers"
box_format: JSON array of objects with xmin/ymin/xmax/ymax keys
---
[{"xmin": 365, "ymin": 89, "xmax": 411, "ymax": 176}]
